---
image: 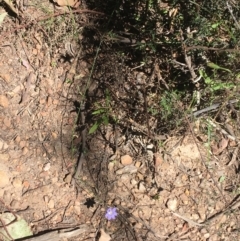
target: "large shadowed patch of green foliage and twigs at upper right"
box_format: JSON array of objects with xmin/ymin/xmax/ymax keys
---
[{"xmin": 85, "ymin": 0, "xmax": 240, "ymax": 137}]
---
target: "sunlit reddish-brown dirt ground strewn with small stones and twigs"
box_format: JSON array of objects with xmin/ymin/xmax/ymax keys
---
[{"xmin": 0, "ymin": 0, "xmax": 240, "ymax": 241}]
